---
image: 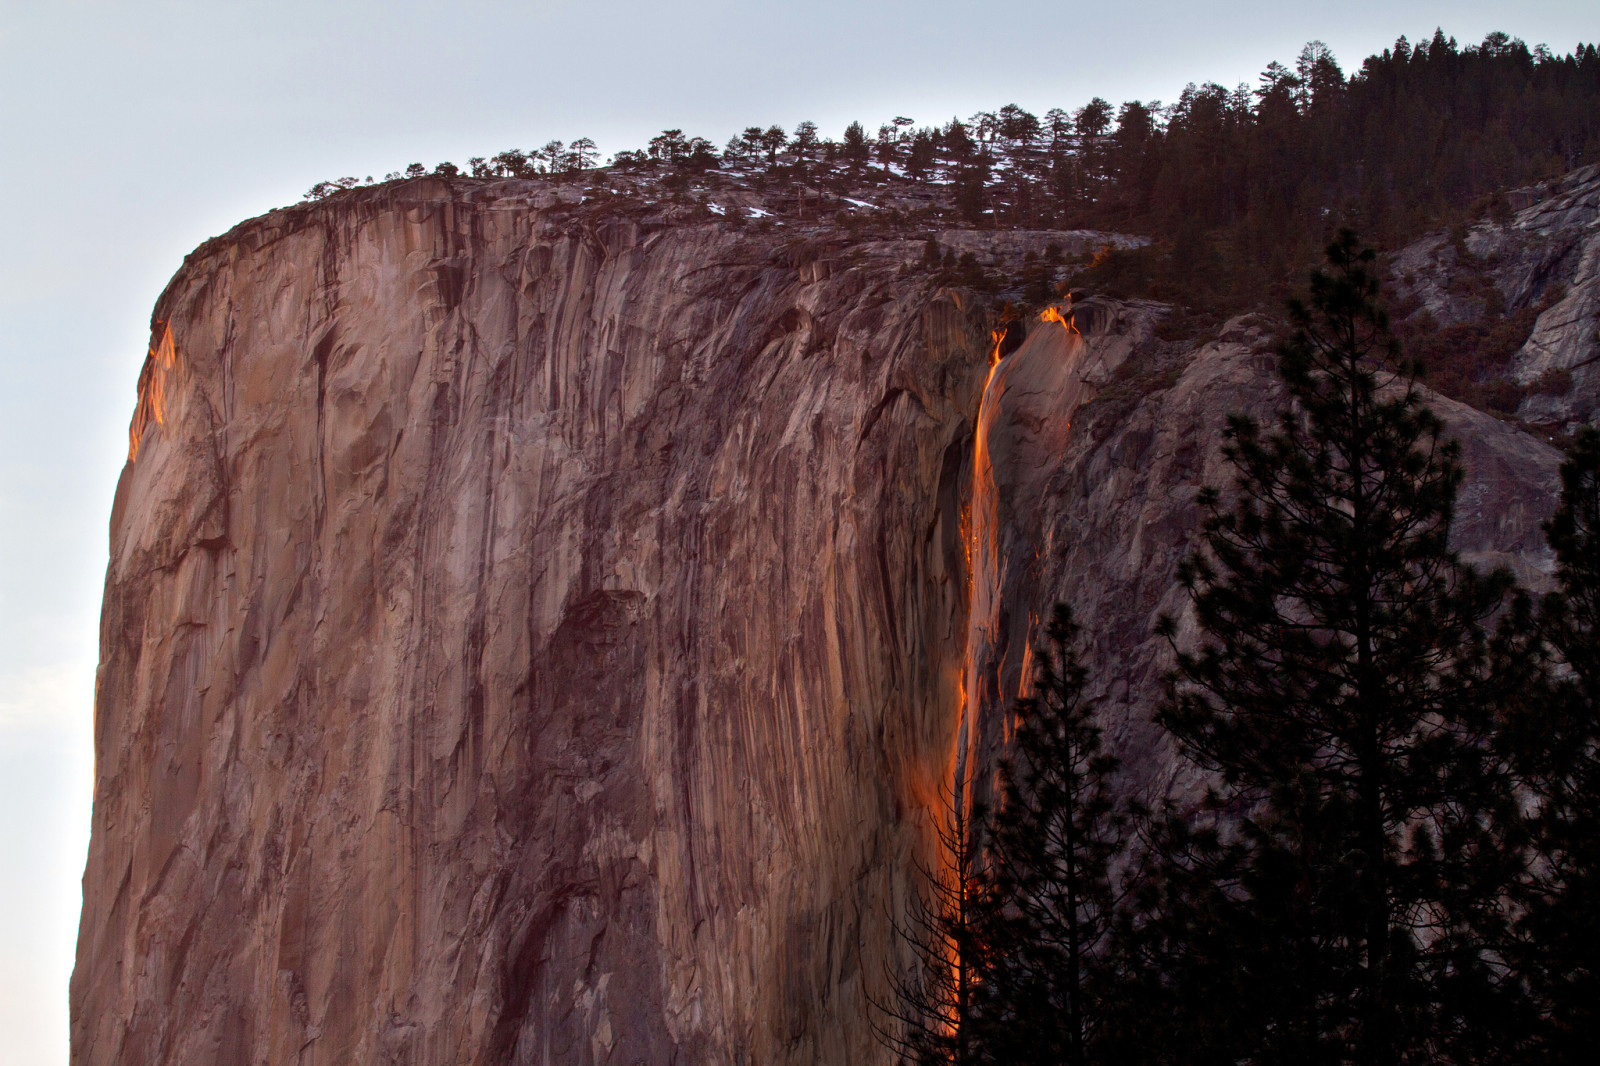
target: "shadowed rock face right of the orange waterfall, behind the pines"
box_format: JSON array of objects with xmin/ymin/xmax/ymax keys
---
[{"xmin": 953, "ymin": 312, "xmax": 1560, "ymax": 809}]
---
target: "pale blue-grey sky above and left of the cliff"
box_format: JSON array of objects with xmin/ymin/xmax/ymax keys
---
[{"xmin": 0, "ymin": 0, "xmax": 1600, "ymax": 1066}]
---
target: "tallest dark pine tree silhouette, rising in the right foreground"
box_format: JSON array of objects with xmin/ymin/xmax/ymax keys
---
[{"xmin": 1145, "ymin": 230, "xmax": 1528, "ymax": 1066}]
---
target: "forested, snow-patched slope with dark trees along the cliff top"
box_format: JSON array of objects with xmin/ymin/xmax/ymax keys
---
[{"xmin": 307, "ymin": 30, "xmax": 1600, "ymax": 311}]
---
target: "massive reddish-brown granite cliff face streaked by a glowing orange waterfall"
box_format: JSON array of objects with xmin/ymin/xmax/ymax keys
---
[{"xmin": 72, "ymin": 181, "xmax": 1557, "ymax": 1066}]
